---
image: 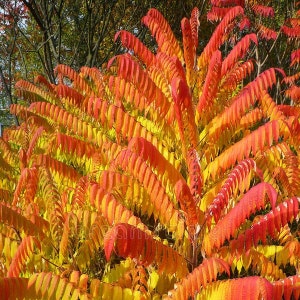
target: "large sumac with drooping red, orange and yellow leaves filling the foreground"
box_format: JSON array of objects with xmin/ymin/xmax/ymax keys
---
[{"xmin": 0, "ymin": 6, "xmax": 300, "ymax": 299}]
